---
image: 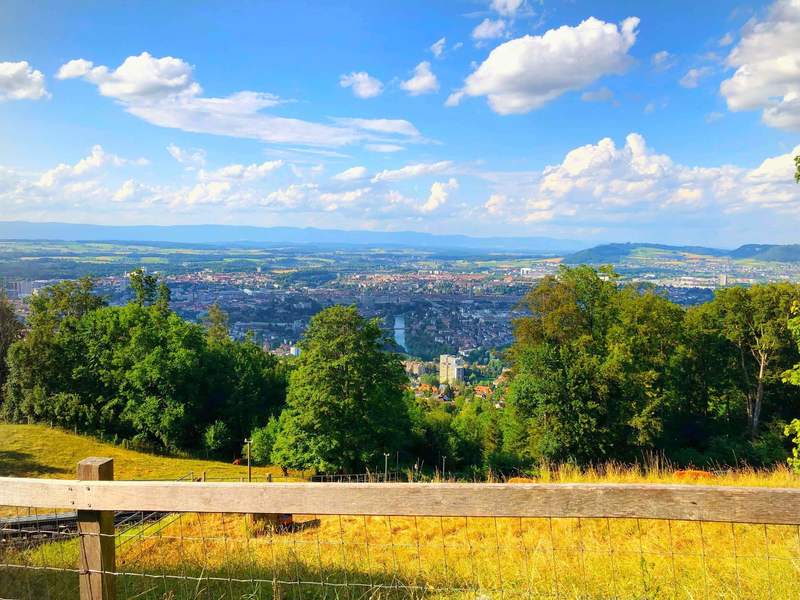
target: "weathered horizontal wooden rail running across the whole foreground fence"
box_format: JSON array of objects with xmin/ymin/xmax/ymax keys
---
[{"xmin": 0, "ymin": 477, "xmax": 800, "ymax": 525}]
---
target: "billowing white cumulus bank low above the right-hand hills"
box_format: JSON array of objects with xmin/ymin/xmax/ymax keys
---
[{"xmin": 484, "ymin": 133, "xmax": 800, "ymax": 227}]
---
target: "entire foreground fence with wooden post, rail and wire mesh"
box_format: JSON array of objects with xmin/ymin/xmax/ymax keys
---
[{"xmin": 0, "ymin": 458, "xmax": 800, "ymax": 600}]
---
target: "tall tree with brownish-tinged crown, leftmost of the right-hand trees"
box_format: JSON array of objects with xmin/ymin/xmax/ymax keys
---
[{"xmin": 507, "ymin": 266, "xmax": 621, "ymax": 462}]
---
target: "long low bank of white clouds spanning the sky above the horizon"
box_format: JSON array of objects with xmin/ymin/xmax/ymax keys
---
[{"xmin": 0, "ymin": 133, "xmax": 800, "ymax": 241}]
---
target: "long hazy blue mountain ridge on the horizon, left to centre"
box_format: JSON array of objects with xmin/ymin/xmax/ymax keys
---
[{"xmin": 0, "ymin": 221, "xmax": 588, "ymax": 256}]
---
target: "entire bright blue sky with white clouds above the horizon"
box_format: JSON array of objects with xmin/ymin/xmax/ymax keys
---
[{"xmin": 0, "ymin": 0, "xmax": 800, "ymax": 246}]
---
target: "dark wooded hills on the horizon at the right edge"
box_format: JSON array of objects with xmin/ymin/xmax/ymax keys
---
[{"xmin": 564, "ymin": 243, "xmax": 800, "ymax": 265}]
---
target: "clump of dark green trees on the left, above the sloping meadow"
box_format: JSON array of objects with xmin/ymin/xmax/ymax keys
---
[{"xmin": 2, "ymin": 276, "xmax": 286, "ymax": 451}]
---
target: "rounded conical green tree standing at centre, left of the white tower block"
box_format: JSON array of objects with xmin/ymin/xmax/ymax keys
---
[{"xmin": 272, "ymin": 306, "xmax": 409, "ymax": 471}]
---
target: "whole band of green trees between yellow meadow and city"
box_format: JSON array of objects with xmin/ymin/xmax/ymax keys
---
[{"xmin": 0, "ymin": 266, "xmax": 800, "ymax": 475}]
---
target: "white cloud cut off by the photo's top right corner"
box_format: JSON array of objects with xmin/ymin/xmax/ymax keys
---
[{"xmin": 720, "ymin": 0, "xmax": 800, "ymax": 131}]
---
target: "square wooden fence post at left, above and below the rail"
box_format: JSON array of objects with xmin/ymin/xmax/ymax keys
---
[{"xmin": 78, "ymin": 457, "xmax": 116, "ymax": 600}]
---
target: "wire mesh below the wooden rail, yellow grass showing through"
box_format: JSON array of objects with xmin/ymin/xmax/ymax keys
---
[{"xmin": 0, "ymin": 507, "xmax": 800, "ymax": 600}]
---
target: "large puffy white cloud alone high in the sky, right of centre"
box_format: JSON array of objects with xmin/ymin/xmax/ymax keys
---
[{"xmin": 456, "ymin": 17, "xmax": 639, "ymax": 115}]
